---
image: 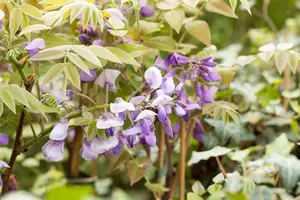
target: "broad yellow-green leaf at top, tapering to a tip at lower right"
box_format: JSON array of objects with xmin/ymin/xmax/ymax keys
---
[{"xmin": 185, "ymin": 20, "xmax": 211, "ymax": 46}]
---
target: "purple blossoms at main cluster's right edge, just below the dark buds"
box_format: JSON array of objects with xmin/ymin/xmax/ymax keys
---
[{"xmin": 195, "ymin": 82, "xmax": 218, "ymax": 105}]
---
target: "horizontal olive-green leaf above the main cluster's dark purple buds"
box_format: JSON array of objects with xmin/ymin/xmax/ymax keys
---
[{"xmin": 143, "ymin": 36, "xmax": 176, "ymax": 52}]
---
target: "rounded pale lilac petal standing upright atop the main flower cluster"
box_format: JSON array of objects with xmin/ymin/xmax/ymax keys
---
[{"xmin": 144, "ymin": 67, "xmax": 162, "ymax": 89}]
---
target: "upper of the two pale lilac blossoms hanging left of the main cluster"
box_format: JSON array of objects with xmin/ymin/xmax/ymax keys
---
[{"xmin": 49, "ymin": 118, "xmax": 68, "ymax": 140}]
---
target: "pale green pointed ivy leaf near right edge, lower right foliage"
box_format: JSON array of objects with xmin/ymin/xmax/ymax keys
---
[{"xmin": 266, "ymin": 133, "xmax": 295, "ymax": 156}]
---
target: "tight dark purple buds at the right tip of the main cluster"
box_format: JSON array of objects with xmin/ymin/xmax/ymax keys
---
[{"xmin": 189, "ymin": 56, "xmax": 221, "ymax": 82}]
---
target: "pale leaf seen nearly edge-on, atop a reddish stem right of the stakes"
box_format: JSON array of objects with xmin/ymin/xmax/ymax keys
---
[{"xmin": 188, "ymin": 146, "xmax": 232, "ymax": 165}]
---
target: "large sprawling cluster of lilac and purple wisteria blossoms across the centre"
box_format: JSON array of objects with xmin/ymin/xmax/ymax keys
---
[{"xmin": 43, "ymin": 53, "xmax": 221, "ymax": 161}]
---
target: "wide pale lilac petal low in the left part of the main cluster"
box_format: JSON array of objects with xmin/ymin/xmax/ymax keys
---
[{"xmin": 91, "ymin": 137, "xmax": 119, "ymax": 154}]
